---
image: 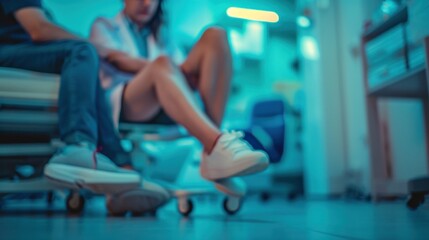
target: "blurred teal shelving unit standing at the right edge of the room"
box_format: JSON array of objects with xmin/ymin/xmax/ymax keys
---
[{"xmin": 361, "ymin": 7, "xmax": 429, "ymax": 201}]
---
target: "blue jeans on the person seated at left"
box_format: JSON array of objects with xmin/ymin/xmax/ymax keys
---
[{"xmin": 0, "ymin": 40, "xmax": 129, "ymax": 165}]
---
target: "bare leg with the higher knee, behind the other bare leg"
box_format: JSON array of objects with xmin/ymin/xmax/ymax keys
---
[{"xmin": 181, "ymin": 28, "xmax": 232, "ymax": 127}]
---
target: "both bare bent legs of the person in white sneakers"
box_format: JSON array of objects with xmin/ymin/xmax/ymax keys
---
[{"xmin": 123, "ymin": 28, "xmax": 232, "ymax": 150}]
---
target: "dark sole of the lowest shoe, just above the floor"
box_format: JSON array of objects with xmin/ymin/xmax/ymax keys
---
[{"xmin": 106, "ymin": 189, "xmax": 169, "ymax": 215}]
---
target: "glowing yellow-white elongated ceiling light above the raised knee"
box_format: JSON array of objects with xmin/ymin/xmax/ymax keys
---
[{"xmin": 226, "ymin": 7, "xmax": 279, "ymax": 23}]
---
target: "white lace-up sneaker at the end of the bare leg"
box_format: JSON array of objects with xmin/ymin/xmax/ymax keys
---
[{"xmin": 200, "ymin": 132, "xmax": 269, "ymax": 181}]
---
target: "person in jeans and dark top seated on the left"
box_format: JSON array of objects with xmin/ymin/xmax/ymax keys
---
[{"xmin": 0, "ymin": 0, "xmax": 168, "ymax": 214}]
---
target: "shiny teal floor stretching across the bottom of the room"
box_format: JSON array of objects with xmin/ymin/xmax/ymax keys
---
[{"xmin": 0, "ymin": 198, "xmax": 429, "ymax": 240}]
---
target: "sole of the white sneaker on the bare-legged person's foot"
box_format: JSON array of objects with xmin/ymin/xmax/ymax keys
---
[{"xmin": 200, "ymin": 158, "xmax": 269, "ymax": 181}]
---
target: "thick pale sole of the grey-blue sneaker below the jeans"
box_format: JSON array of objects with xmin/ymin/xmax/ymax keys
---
[{"xmin": 44, "ymin": 163, "xmax": 141, "ymax": 193}]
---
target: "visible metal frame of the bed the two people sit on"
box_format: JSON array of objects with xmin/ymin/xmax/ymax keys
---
[{"xmin": 0, "ymin": 68, "xmax": 188, "ymax": 198}]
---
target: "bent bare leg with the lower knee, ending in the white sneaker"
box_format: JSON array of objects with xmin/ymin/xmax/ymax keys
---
[{"xmin": 123, "ymin": 56, "xmax": 220, "ymax": 150}]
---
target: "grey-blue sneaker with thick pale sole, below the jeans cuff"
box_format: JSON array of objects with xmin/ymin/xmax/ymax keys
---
[{"xmin": 44, "ymin": 145, "xmax": 141, "ymax": 193}]
